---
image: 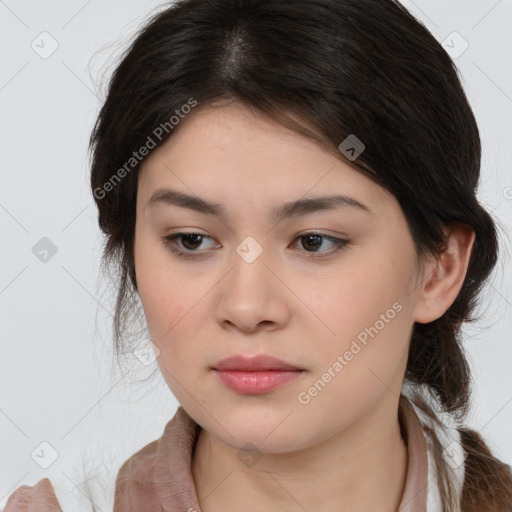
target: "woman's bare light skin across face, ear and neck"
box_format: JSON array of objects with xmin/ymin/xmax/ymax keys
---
[{"xmin": 6, "ymin": 103, "xmax": 474, "ymax": 512}]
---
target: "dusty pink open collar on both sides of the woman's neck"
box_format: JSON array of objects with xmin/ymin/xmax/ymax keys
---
[{"xmin": 114, "ymin": 396, "xmax": 428, "ymax": 512}]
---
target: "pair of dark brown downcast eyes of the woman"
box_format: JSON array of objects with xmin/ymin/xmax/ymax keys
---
[{"xmin": 162, "ymin": 232, "xmax": 348, "ymax": 258}]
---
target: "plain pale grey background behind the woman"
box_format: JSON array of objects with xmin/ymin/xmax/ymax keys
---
[{"xmin": 0, "ymin": 0, "xmax": 512, "ymax": 511}]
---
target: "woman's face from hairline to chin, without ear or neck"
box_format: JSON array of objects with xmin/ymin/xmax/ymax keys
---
[{"xmin": 135, "ymin": 104, "xmax": 426, "ymax": 453}]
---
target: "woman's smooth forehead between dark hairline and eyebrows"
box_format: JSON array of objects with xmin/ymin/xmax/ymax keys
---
[{"xmin": 138, "ymin": 104, "xmax": 394, "ymax": 215}]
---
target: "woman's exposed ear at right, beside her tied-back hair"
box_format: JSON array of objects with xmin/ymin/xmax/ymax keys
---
[{"xmin": 414, "ymin": 223, "xmax": 475, "ymax": 324}]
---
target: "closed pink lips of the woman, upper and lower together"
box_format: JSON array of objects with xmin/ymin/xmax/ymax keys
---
[{"xmin": 212, "ymin": 355, "xmax": 304, "ymax": 395}]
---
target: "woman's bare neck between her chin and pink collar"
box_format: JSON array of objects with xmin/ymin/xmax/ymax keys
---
[{"xmin": 192, "ymin": 394, "xmax": 407, "ymax": 512}]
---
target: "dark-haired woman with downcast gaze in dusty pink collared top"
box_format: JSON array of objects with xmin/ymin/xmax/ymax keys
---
[{"xmin": 6, "ymin": 0, "xmax": 512, "ymax": 512}]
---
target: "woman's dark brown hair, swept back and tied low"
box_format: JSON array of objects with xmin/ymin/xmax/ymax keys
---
[{"xmin": 90, "ymin": 0, "xmax": 512, "ymax": 512}]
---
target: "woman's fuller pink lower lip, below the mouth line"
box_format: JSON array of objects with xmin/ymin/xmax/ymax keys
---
[{"xmin": 214, "ymin": 370, "xmax": 302, "ymax": 395}]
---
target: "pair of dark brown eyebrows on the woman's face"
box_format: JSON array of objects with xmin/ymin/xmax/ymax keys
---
[{"xmin": 146, "ymin": 188, "xmax": 373, "ymax": 220}]
